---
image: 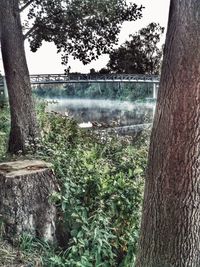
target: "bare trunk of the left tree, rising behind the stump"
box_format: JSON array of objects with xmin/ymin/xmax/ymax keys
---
[{"xmin": 0, "ymin": 0, "xmax": 37, "ymax": 153}]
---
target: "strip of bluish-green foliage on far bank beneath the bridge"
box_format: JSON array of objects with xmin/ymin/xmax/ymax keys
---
[{"xmin": 33, "ymin": 82, "xmax": 153, "ymax": 101}]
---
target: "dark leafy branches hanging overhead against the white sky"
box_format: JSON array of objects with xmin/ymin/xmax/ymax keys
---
[{"xmin": 21, "ymin": 0, "xmax": 143, "ymax": 64}]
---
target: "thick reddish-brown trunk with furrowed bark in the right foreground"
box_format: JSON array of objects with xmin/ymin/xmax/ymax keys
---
[{"xmin": 135, "ymin": 0, "xmax": 200, "ymax": 267}]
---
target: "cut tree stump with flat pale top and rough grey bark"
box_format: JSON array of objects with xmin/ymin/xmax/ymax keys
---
[{"xmin": 0, "ymin": 160, "xmax": 57, "ymax": 244}]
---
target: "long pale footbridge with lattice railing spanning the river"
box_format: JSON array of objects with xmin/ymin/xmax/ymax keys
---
[{"xmin": 0, "ymin": 73, "xmax": 160, "ymax": 98}]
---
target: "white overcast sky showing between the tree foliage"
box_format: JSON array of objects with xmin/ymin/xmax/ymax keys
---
[{"xmin": 0, "ymin": 0, "xmax": 170, "ymax": 74}]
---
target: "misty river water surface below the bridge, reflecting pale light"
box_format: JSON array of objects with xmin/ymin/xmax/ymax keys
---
[{"xmin": 46, "ymin": 98, "xmax": 155, "ymax": 126}]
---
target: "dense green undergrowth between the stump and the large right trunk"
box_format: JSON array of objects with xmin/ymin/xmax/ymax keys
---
[{"xmin": 0, "ymin": 103, "xmax": 147, "ymax": 267}]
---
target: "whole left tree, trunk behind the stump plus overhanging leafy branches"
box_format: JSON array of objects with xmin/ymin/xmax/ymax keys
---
[{"xmin": 0, "ymin": 0, "xmax": 142, "ymax": 153}]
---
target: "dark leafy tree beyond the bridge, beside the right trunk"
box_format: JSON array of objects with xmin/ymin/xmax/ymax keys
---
[{"xmin": 107, "ymin": 23, "xmax": 164, "ymax": 74}]
